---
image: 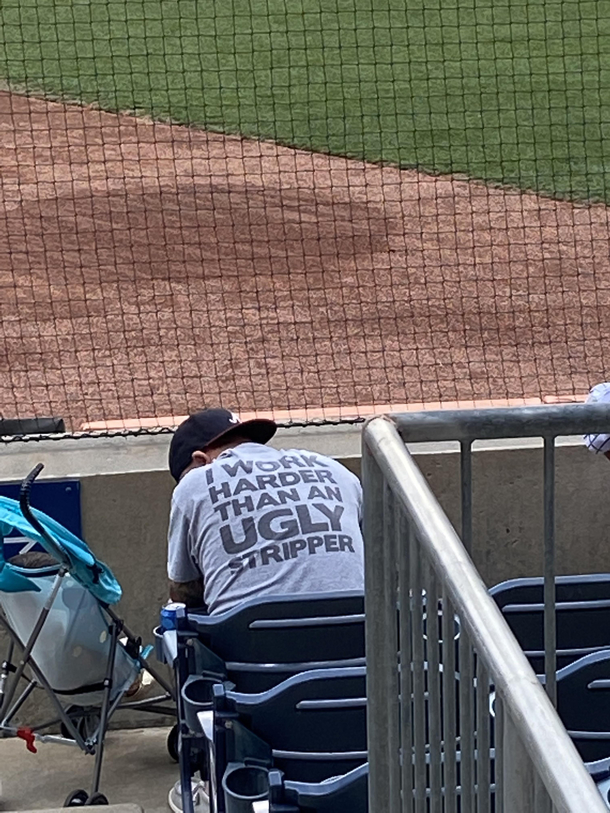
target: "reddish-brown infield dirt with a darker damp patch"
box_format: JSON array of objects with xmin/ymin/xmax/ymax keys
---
[{"xmin": 0, "ymin": 92, "xmax": 610, "ymax": 428}]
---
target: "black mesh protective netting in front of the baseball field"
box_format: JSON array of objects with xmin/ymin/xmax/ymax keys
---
[{"xmin": 0, "ymin": 0, "xmax": 610, "ymax": 430}]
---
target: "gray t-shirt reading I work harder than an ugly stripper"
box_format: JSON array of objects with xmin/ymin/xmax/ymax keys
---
[{"xmin": 167, "ymin": 443, "xmax": 364, "ymax": 613}]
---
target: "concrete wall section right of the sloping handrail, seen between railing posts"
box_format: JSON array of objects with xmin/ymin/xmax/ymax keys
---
[{"xmin": 418, "ymin": 440, "xmax": 610, "ymax": 586}]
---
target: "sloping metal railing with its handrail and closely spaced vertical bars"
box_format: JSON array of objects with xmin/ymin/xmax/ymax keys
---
[{"xmin": 363, "ymin": 416, "xmax": 610, "ymax": 813}]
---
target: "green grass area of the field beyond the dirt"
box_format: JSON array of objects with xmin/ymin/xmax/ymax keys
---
[{"xmin": 0, "ymin": 0, "xmax": 610, "ymax": 200}]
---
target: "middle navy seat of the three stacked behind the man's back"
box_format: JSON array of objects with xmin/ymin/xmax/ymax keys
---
[{"xmin": 188, "ymin": 667, "xmax": 367, "ymax": 804}]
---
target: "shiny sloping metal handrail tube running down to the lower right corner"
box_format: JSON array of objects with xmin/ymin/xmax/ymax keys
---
[{"xmin": 363, "ymin": 416, "xmax": 610, "ymax": 813}]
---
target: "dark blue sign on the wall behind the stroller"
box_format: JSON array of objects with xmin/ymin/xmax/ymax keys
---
[{"xmin": 0, "ymin": 480, "xmax": 82, "ymax": 559}]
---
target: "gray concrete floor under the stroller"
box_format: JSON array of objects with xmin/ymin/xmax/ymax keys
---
[{"xmin": 0, "ymin": 728, "xmax": 178, "ymax": 813}]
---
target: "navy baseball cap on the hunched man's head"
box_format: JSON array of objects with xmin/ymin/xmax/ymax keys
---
[{"xmin": 169, "ymin": 408, "xmax": 277, "ymax": 482}]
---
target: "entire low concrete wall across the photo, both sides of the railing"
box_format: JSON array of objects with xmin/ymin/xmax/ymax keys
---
[{"xmin": 0, "ymin": 426, "xmax": 610, "ymax": 728}]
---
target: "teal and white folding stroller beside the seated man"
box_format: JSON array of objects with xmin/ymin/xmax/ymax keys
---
[{"xmin": 0, "ymin": 464, "xmax": 176, "ymax": 807}]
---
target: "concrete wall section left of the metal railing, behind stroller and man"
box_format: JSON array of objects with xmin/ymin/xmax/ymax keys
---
[{"xmin": 0, "ymin": 426, "xmax": 360, "ymax": 639}]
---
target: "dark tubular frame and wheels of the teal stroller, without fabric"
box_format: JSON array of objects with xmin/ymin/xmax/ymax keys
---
[{"xmin": 0, "ymin": 464, "xmax": 176, "ymax": 807}]
